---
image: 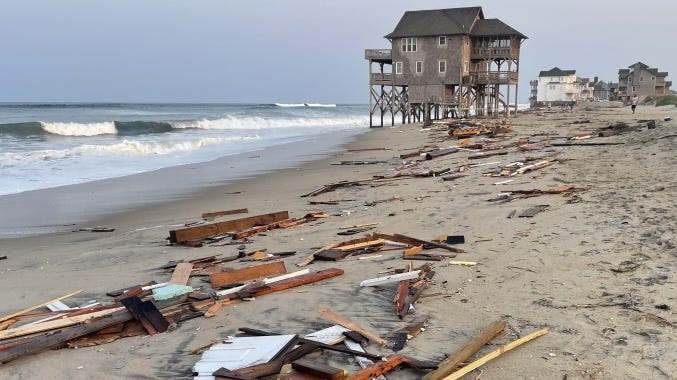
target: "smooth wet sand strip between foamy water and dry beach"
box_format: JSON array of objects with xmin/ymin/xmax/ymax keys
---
[{"xmin": 0, "ymin": 128, "xmax": 368, "ymax": 241}]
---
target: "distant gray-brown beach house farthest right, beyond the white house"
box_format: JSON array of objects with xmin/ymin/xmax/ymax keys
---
[{"xmin": 615, "ymin": 62, "xmax": 672, "ymax": 102}]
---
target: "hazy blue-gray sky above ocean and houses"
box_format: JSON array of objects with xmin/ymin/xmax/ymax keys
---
[{"xmin": 0, "ymin": 0, "xmax": 677, "ymax": 103}]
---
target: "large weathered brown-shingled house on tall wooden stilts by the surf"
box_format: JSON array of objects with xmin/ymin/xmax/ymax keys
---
[{"xmin": 365, "ymin": 7, "xmax": 527, "ymax": 126}]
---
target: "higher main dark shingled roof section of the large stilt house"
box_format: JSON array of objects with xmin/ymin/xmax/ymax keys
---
[{"xmin": 385, "ymin": 7, "xmax": 484, "ymax": 38}]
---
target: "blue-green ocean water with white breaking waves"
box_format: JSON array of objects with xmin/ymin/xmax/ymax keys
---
[{"xmin": 0, "ymin": 103, "xmax": 369, "ymax": 195}]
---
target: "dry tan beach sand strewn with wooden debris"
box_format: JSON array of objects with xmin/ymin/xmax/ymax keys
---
[{"xmin": 0, "ymin": 102, "xmax": 677, "ymax": 380}]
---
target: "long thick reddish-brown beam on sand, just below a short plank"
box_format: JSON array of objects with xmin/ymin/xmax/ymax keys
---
[{"xmin": 169, "ymin": 211, "xmax": 289, "ymax": 244}]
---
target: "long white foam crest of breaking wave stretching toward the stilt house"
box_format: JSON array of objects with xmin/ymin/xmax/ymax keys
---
[{"xmin": 172, "ymin": 116, "xmax": 369, "ymax": 129}]
